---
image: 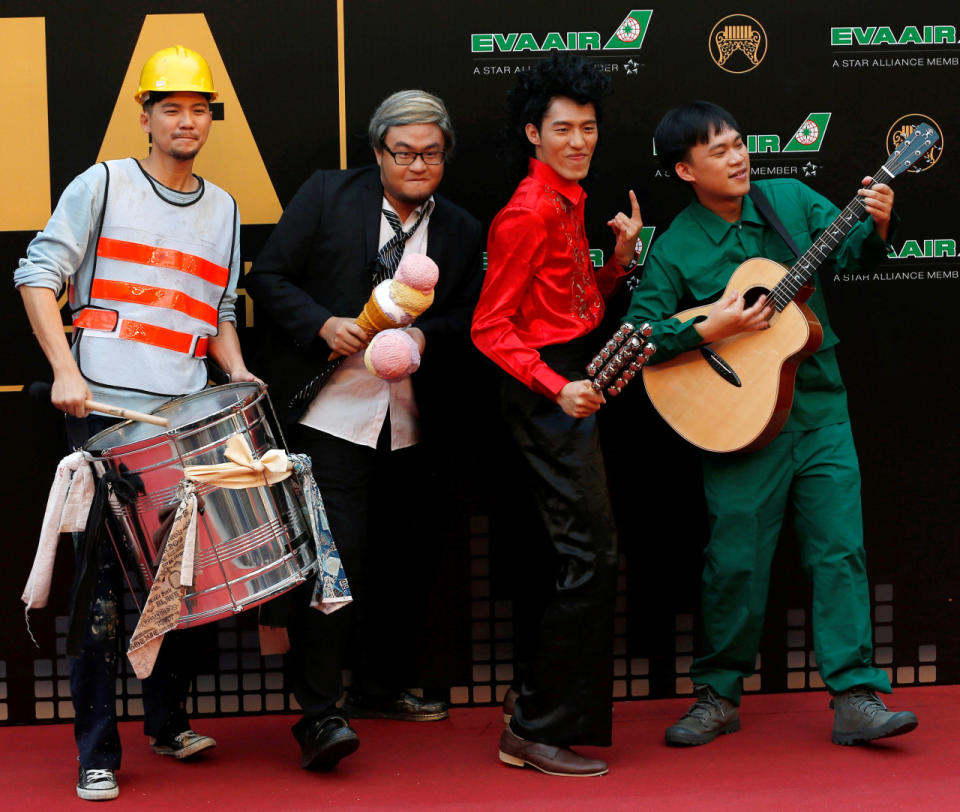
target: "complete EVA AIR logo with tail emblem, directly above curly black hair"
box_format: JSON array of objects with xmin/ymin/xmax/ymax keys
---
[{"xmin": 470, "ymin": 9, "xmax": 653, "ymax": 54}]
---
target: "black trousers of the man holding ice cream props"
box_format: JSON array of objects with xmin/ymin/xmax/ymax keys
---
[{"xmin": 284, "ymin": 420, "xmax": 422, "ymax": 720}]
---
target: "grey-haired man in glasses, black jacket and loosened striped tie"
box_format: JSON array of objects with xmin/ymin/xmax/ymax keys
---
[{"xmin": 245, "ymin": 90, "xmax": 483, "ymax": 769}]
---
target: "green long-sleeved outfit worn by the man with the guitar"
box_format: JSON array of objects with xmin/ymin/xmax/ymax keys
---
[{"xmin": 625, "ymin": 179, "xmax": 890, "ymax": 704}]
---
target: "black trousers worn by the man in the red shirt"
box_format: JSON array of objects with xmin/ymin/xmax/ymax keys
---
[{"xmin": 501, "ymin": 339, "xmax": 617, "ymax": 746}]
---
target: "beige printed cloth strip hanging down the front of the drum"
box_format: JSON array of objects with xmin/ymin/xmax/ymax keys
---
[{"xmin": 127, "ymin": 479, "xmax": 197, "ymax": 679}]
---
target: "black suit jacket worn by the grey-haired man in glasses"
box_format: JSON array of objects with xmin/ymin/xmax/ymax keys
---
[{"xmin": 244, "ymin": 165, "xmax": 483, "ymax": 436}]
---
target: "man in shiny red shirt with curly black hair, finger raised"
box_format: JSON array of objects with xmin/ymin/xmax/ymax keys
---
[{"xmin": 472, "ymin": 54, "xmax": 643, "ymax": 775}]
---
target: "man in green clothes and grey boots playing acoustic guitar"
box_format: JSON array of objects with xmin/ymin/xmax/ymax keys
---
[{"xmin": 625, "ymin": 102, "xmax": 917, "ymax": 745}]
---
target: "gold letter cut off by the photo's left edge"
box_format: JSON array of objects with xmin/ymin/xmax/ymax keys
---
[{"xmin": 0, "ymin": 17, "xmax": 50, "ymax": 231}]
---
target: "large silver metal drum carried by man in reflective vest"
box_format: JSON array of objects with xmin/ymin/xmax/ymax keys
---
[{"xmin": 84, "ymin": 383, "xmax": 317, "ymax": 629}]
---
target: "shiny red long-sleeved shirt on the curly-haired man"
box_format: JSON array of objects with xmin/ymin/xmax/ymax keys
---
[{"xmin": 471, "ymin": 158, "xmax": 625, "ymax": 400}]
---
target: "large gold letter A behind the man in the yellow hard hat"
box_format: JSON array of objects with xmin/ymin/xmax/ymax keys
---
[{"xmin": 99, "ymin": 14, "xmax": 282, "ymax": 225}]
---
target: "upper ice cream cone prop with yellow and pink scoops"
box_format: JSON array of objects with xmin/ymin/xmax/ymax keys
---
[{"xmin": 330, "ymin": 254, "xmax": 440, "ymax": 361}]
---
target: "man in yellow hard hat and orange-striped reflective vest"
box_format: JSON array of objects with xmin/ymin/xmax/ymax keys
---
[{"xmin": 14, "ymin": 45, "xmax": 257, "ymax": 800}]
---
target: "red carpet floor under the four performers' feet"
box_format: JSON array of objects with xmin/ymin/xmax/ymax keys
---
[{"xmin": 0, "ymin": 686, "xmax": 960, "ymax": 811}]
